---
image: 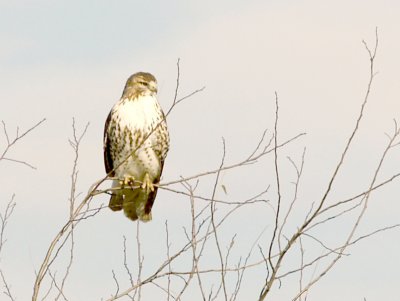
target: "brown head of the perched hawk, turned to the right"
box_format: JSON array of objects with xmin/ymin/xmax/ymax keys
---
[{"xmin": 122, "ymin": 72, "xmax": 157, "ymax": 99}]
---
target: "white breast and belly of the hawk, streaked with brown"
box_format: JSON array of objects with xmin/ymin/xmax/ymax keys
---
[{"xmin": 107, "ymin": 95, "xmax": 169, "ymax": 180}]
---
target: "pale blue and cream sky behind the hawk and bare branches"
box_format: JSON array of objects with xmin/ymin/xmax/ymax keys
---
[{"xmin": 0, "ymin": 0, "xmax": 400, "ymax": 301}]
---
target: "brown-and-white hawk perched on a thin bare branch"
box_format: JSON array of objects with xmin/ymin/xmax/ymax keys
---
[{"xmin": 104, "ymin": 72, "xmax": 169, "ymax": 221}]
